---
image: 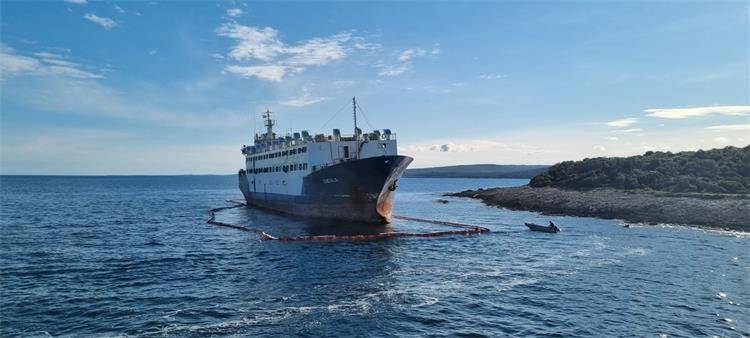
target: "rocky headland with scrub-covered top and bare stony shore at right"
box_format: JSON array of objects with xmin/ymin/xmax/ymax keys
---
[{"xmin": 449, "ymin": 146, "xmax": 750, "ymax": 232}]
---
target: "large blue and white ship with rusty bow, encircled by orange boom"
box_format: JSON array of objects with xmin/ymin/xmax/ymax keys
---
[{"xmin": 239, "ymin": 98, "xmax": 413, "ymax": 224}]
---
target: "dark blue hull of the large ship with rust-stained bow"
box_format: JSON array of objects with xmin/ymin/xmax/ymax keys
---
[{"xmin": 239, "ymin": 155, "xmax": 413, "ymax": 223}]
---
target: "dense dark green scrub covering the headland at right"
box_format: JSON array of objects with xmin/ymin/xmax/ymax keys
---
[{"xmin": 529, "ymin": 146, "xmax": 750, "ymax": 194}]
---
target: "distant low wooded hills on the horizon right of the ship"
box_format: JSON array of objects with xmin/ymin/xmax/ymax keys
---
[{"xmin": 404, "ymin": 164, "xmax": 549, "ymax": 178}]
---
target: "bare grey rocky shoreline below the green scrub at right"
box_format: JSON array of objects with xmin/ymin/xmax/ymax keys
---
[{"xmin": 446, "ymin": 186, "xmax": 750, "ymax": 232}]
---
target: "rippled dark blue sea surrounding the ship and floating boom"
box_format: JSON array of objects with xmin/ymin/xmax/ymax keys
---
[{"xmin": 0, "ymin": 176, "xmax": 750, "ymax": 337}]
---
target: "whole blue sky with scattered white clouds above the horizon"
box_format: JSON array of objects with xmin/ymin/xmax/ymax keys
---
[{"xmin": 0, "ymin": 0, "xmax": 750, "ymax": 175}]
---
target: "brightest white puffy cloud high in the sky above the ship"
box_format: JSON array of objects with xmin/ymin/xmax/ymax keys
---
[{"xmin": 216, "ymin": 22, "xmax": 361, "ymax": 81}]
